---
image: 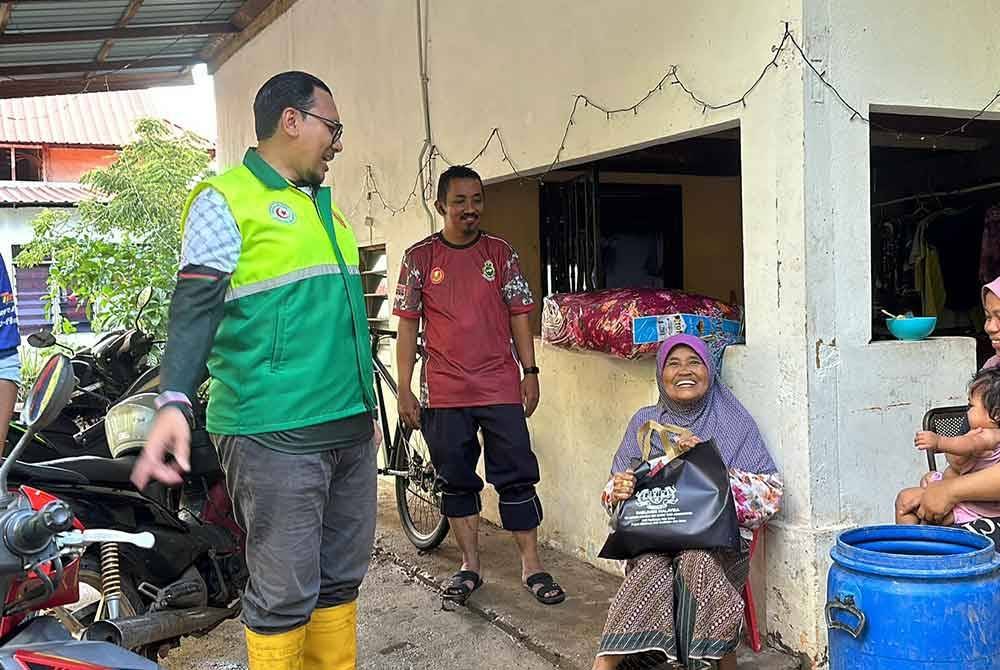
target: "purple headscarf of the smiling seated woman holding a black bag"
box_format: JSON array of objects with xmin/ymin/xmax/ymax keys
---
[{"xmin": 611, "ymin": 335, "xmax": 777, "ymax": 474}]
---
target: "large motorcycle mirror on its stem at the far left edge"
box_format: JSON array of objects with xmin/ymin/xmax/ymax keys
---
[{"xmin": 0, "ymin": 354, "xmax": 76, "ymax": 506}]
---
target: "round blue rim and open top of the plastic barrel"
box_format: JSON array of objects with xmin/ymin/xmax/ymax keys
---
[{"xmin": 830, "ymin": 526, "xmax": 1000, "ymax": 579}]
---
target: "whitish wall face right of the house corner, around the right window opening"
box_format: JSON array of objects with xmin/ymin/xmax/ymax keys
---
[{"xmin": 784, "ymin": 0, "xmax": 1000, "ymax": 655}]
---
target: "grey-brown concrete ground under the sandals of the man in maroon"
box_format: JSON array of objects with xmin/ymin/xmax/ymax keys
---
[{"xmin": 154, "ymin": 486, "xmax": 799, "ymax": 670}]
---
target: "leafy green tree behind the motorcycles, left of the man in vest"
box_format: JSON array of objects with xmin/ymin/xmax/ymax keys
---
[{"xmin": 15, "ymin": 119, "xmax": 211, "ymax": 338}]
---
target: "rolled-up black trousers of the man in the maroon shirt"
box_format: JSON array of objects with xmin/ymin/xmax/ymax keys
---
[{"xmin": 420, "ymin": 405, "xmax": 542, "ymax": 530}]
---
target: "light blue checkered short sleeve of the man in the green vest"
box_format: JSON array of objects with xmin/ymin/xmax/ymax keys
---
[{"xmin": 181, "ymin": 188, "xmax": 243, "ymax": 274}]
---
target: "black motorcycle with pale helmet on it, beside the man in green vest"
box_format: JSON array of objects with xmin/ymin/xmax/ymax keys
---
[{"xmin": 10, "ymin": 393, "xmax": 247, "ymax": 658}]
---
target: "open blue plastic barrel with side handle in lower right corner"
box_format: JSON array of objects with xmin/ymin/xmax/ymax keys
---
[{"xmin": 826, "ymin": 526, "xmax": 1000, "ymax": 670}]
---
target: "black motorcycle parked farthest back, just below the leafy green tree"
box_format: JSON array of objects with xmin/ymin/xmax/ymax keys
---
[{"xmin": 4, "ymin": 289, "xmax": 159, "ymax": 463}]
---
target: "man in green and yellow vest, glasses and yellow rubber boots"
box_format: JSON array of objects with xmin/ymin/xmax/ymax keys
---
[{"xmin": 133, "ymin": 72, "xmax": 376, "ymax": 670}]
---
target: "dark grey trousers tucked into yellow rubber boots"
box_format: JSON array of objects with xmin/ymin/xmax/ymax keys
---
[{"xmin": 212, "ymin": 435, "xmax": 377, "ymax": 634}]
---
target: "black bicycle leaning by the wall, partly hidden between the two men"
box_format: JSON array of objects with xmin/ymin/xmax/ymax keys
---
[{"xmin": 371, "ymin": 328, "xmax": 449, "ymax": 551}]
